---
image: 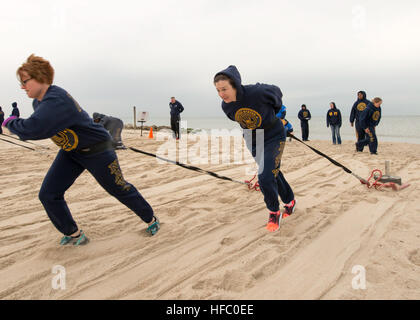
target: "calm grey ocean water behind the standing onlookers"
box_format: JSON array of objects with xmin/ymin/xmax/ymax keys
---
[{"xmin": 123, "ymin": 116, "xmax": 420, "ymax": 144}]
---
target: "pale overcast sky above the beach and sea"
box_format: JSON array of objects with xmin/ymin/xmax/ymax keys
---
[{"xmin": 0, "ymin": 0, "xmax": 420, "ymax": 118}]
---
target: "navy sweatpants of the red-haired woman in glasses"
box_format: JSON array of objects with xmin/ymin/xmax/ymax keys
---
[{"xmin": 39, "ymin": 150, "xmax": 153, "ymax": 236}]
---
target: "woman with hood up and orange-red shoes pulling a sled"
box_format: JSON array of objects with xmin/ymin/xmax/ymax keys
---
[{"xmin": 213, "ymin": 65, "xmax": 296, "ymax": 232}]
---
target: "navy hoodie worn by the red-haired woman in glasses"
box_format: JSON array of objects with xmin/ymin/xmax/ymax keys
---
[{"xmin": 7, "ymin": 85, "xmax": 111, "ymax": 151}]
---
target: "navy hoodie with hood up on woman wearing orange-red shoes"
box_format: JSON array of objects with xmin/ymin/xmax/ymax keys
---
[{"xmin": 216, "ymin": 66, "xmax": 283, "ymax": 130}]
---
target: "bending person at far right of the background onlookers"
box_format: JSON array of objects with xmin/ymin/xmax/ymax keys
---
[{"xmin": 356, "ymin": 97, "xmax": 382, "ymax": 155}]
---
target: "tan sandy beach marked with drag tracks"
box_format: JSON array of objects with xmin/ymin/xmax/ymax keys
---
[{"xmin": 0, "ymin": 130, "xmax": 420, "ymax": 300}]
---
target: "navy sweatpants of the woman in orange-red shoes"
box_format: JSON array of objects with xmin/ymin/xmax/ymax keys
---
[{"xmin": 244, "ymin": 122, "xmax": 295, "ymax": 212}]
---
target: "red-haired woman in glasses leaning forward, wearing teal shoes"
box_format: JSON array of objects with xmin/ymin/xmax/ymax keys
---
[{"xmin": 3, "ymin": 54, "xmax": 160, "ymax": 245}]
